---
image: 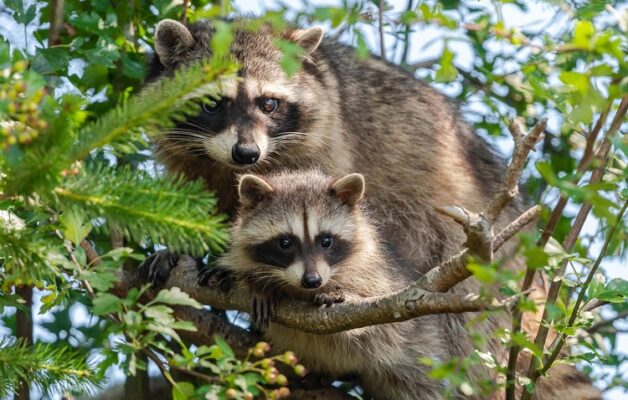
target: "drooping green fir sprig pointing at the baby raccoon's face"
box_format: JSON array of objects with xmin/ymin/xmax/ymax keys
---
[{"xmin": 54, "ymin": 166, "xmax": 226, "ymax": 254}]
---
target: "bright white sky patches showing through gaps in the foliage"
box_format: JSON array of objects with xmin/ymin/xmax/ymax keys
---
[{"xmin": 0, "ymin": 0, "xmax": 628, "ymax": 400}]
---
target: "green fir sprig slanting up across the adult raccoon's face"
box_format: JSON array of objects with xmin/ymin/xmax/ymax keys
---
[{"xmin": 71, "ymin": 65, "xmax": 233, "ymax": 160}]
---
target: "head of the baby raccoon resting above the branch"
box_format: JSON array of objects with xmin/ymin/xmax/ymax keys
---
[{"xmin": 233, "ymin": 173, "xmax": 364, "ymax": 291}]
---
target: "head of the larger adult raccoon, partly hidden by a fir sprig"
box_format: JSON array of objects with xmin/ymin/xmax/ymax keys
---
[{"xmin": 155, "ymin": 20, "xmax": 323, "ymax": 169}]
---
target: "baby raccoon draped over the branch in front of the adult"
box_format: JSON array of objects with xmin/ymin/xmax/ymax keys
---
[{"xmin": 209, "ymin": 171, "xmax": 451, "ymax": 400}]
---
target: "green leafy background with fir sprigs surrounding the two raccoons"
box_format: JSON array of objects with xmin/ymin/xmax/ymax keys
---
[{"xmin": 0, "ymin": 0, "xmax": 628, "ymax": 399}]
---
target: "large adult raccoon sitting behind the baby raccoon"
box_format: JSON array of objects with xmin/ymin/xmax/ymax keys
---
[{"xmin": 147, "ymin": 20, "xmax": 600, "ymax": 398}]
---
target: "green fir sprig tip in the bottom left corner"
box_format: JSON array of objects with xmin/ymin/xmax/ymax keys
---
[{"xmin": 0, "ymin": 338, "xmax": 102, "ymax": 398}]
